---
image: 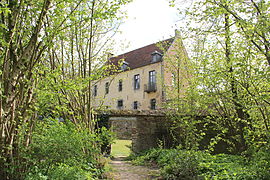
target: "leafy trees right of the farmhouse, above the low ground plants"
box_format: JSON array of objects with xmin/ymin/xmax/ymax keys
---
[{"xmin": 168, "ymin": 0, "xmax": 270, "ymax": 152}]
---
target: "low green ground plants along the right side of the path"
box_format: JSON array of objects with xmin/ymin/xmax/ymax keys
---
[{"xmin": 131, "ymin": 149, "xmax": 270, "ymax": 180}]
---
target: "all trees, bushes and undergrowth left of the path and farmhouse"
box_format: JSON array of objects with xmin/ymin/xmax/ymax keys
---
[{"xmin": 0, "ymin": 0, "xmax": 129, "ymax": 179}]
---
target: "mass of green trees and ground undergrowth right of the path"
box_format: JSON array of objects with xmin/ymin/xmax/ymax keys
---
[{"xmin": 153, "ymin": 0, "xmax": 270, "ymax": 179}]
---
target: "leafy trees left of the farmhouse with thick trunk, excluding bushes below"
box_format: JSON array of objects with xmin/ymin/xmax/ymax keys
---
[{"xmin": 0, "ymin": 0, "xmax": 129, "ymax": 179}]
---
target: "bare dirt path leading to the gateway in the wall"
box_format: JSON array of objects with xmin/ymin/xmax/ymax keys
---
[{"xmin": 110, "ymin": 157, "xmax": 160, "ymax": 180}]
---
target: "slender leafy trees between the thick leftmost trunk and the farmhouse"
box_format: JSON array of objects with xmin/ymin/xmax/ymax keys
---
[{"xmin": 39, "ymin": 1, "xmax": 131, "ymax": 130}]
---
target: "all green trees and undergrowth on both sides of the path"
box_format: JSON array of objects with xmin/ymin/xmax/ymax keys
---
[{"xmin": 0, "ymin": 0, "xmax": 270, "ymax": 179}]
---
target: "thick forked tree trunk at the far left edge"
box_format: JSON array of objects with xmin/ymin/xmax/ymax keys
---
[{"xmin": 0, "ymin": 0, "xmax": 51, "ymax": 179}]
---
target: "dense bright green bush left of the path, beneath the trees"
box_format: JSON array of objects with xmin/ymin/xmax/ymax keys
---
[{"xmin": 21, "ymin": 119, "xmax": 103, "ymax": 179}]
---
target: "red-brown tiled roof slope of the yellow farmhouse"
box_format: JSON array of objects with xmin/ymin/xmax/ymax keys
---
[{"xmin": 110, "ymin": 38, "xmax": 174, "ymax": 69}]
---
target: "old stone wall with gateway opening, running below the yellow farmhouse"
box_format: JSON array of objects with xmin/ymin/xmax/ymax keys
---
[{"xmin": 109, "ymin": 111, "xmax": 240, "ymax": 153}]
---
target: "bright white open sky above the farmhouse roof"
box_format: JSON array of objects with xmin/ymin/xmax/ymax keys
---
[{"xmin": 115, "ymin": 0, "xmax": 179, "ymax": 55}]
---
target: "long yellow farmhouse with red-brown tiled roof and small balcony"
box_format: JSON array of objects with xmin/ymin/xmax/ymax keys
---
[{"xmin": 92, "ymin": 31, "xmax": 189, "ymax": 110}]
